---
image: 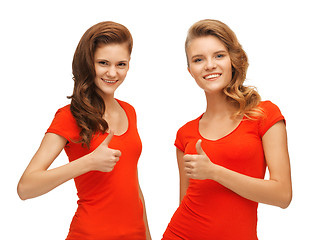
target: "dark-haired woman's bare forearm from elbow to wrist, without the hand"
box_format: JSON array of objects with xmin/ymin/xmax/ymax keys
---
[{"xmin": 17, "ymin": 155, "xmax": 90, "ymax": 200}]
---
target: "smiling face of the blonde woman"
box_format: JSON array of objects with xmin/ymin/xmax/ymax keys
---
[{"xmin": 187, "ymin": 36, "xmax": 232, "ymax": 93}]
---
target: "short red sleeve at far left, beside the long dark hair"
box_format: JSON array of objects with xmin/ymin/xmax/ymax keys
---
[{"xmin": 46, "ymin": 105, "xmax": 79, "ymax": 142}]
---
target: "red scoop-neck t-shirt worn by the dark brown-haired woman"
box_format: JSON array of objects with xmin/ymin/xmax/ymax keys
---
[{"xmin": 47, "ymin": 100, "xmax": 146, "ymax": 240}]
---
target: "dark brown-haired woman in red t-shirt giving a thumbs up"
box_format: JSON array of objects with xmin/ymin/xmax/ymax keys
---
[{"xmin": 18, "ymin": 21, "xmax": 151, "ymax": 240}]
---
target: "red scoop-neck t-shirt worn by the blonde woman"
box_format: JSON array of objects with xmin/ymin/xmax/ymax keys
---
[{"xmin": 163, "ymin": 101, "xmax": 284, "ymax": 240}]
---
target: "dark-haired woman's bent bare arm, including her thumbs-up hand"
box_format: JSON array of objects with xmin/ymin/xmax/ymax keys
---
[{"xmin": 17, "ymin": 130, "xmax": 120, "ymax": 200}]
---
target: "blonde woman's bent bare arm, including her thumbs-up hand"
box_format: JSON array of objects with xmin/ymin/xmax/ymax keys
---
[{"xmin": 185, "ymin": 121, "xmax": 292, "ymax": 208}]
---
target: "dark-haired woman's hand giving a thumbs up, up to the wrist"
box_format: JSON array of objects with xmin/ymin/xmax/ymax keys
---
[{"xmin": 89, "ymin": 131, "xmax": 121, "ymax": 172}]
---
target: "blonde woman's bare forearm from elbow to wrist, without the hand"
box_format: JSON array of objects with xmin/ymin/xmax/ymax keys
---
[{"xmin": 211, "ymin": 165, "xmax": 292, "ymax": 208}]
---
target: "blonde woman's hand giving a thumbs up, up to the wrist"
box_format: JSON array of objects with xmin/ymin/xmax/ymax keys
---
[{"xmin": 183, "ymin": 139, "xmax": 214, "ymax": 180}]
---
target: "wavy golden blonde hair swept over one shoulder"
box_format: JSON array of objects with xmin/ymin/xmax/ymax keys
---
[{"xmin": 185, "ymin": 19, "xmax": 262, "ymax": 119}]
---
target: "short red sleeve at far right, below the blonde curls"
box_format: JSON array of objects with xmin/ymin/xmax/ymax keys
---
[{"xmin": 259, "ymin": 101, "xmax": 286, "ymax": 137}]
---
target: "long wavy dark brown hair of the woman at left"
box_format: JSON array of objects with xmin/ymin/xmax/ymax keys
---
[{"xmin": 68, "ymin": 21, "xmax": 133, "ymax": 148}]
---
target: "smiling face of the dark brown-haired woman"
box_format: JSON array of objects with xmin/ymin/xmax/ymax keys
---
[{"xmin": 94, "ymin": 43, "xmax": 130, "ymax": 98}]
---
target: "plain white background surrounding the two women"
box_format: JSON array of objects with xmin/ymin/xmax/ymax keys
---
[{"xmin": 0, "ymin": 0, "xmax": 328, "ymax": 240}]
